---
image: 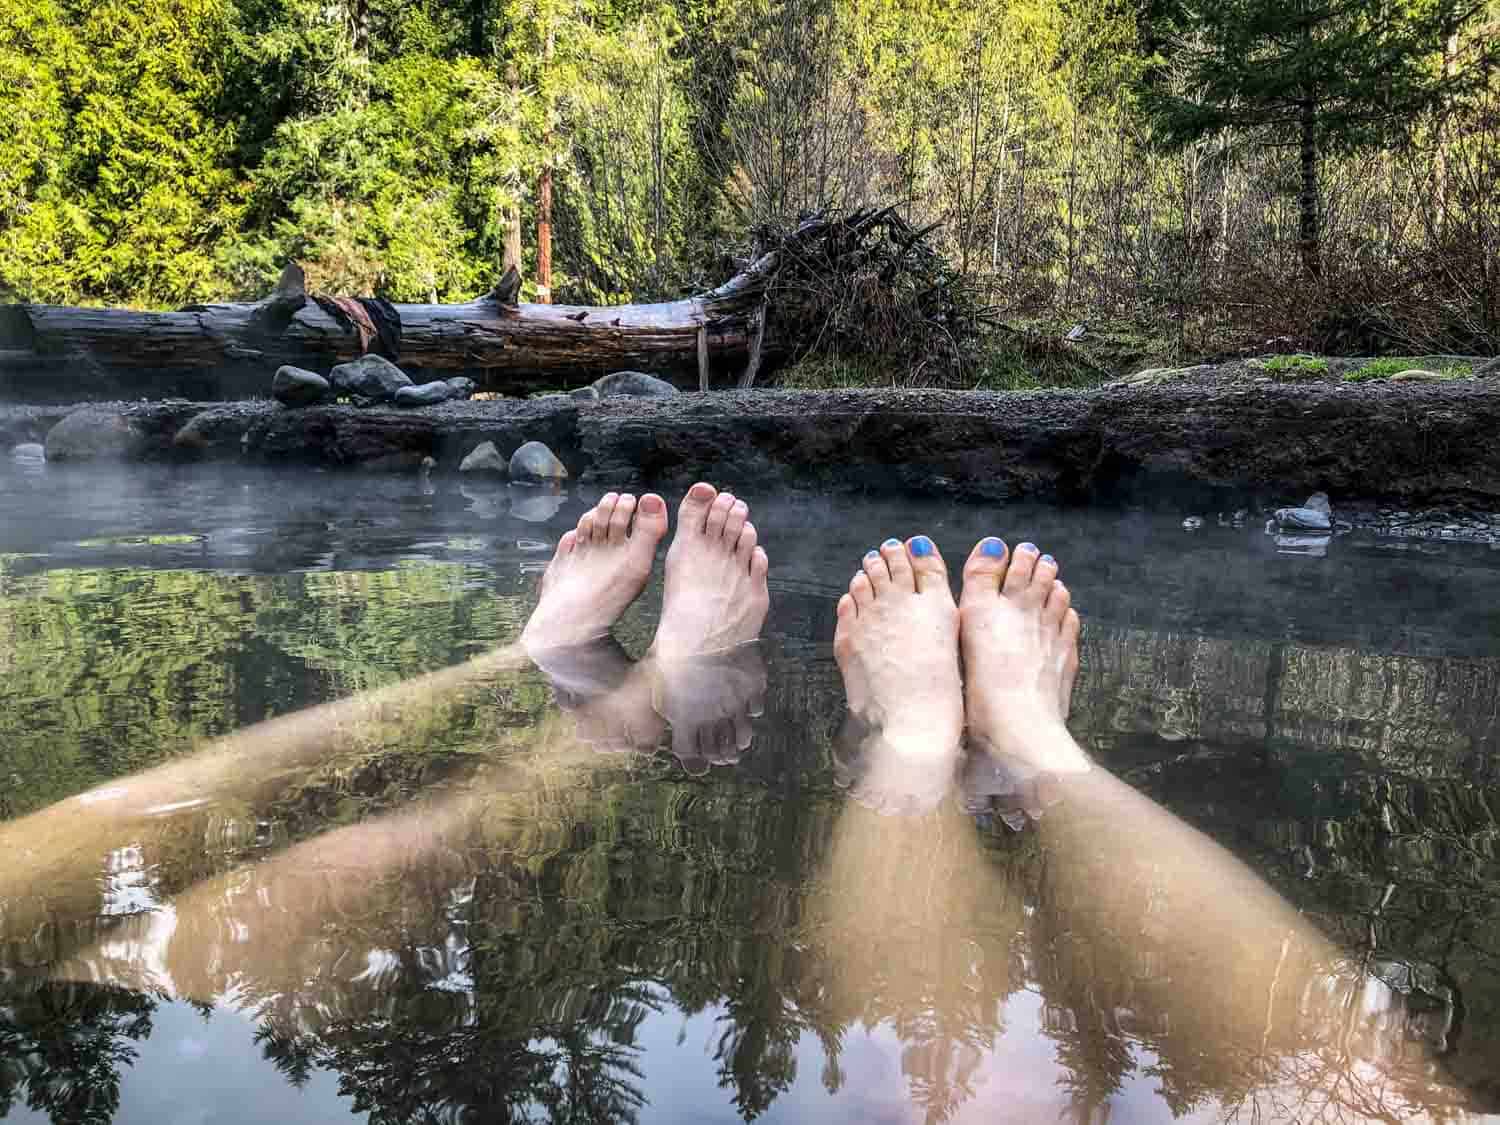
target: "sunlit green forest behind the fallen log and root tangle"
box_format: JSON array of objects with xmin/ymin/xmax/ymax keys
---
[{"xmin": 0, "ymin": 0, "xmax": 1500, "ymax": 386}]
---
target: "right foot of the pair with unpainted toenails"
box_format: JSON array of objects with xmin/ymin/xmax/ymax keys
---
[{"xmin": 651, "ymin": 483, "xmax": 771, "ymax": 665}]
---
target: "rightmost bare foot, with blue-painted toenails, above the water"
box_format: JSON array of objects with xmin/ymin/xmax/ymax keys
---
[{"xmin": 959, "ymin": 539, "xmax": 1089, "ymax": 771}]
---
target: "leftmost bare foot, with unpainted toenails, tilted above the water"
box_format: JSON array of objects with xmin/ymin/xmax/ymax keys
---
[{"xmin": 521, "ymin": 492, "xmax": 666, "ymax": 653}]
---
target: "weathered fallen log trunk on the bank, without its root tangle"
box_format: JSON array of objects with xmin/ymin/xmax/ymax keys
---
[{"xmin": 0, "ymin": 252, "xmax": 776, "ymax": 402}]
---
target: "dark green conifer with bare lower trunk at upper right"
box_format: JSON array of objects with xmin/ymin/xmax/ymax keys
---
[{"xmin": 1145, "ymin": 0, "xmax": 1475, "ymax": 276}]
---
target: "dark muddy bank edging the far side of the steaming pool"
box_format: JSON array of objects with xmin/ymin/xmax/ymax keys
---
[{"xmin": 0, "ymin": 380, "xmax": 1500, "ymax": 510}]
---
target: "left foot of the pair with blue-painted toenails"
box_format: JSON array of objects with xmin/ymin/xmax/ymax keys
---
[{"xmin": 834, "ymin": 536, "xmax": 963, "ymax": 759}]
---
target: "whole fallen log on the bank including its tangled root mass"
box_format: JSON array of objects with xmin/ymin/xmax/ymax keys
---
[{"xmin": 0, "ymin": 209, "xmax": 974, "ymax": 401}]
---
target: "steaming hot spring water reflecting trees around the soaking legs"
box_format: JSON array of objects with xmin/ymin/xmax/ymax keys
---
[{"xmin": 0, "ymin": 465, "xmax": 1500, "ymax": 1124}]
